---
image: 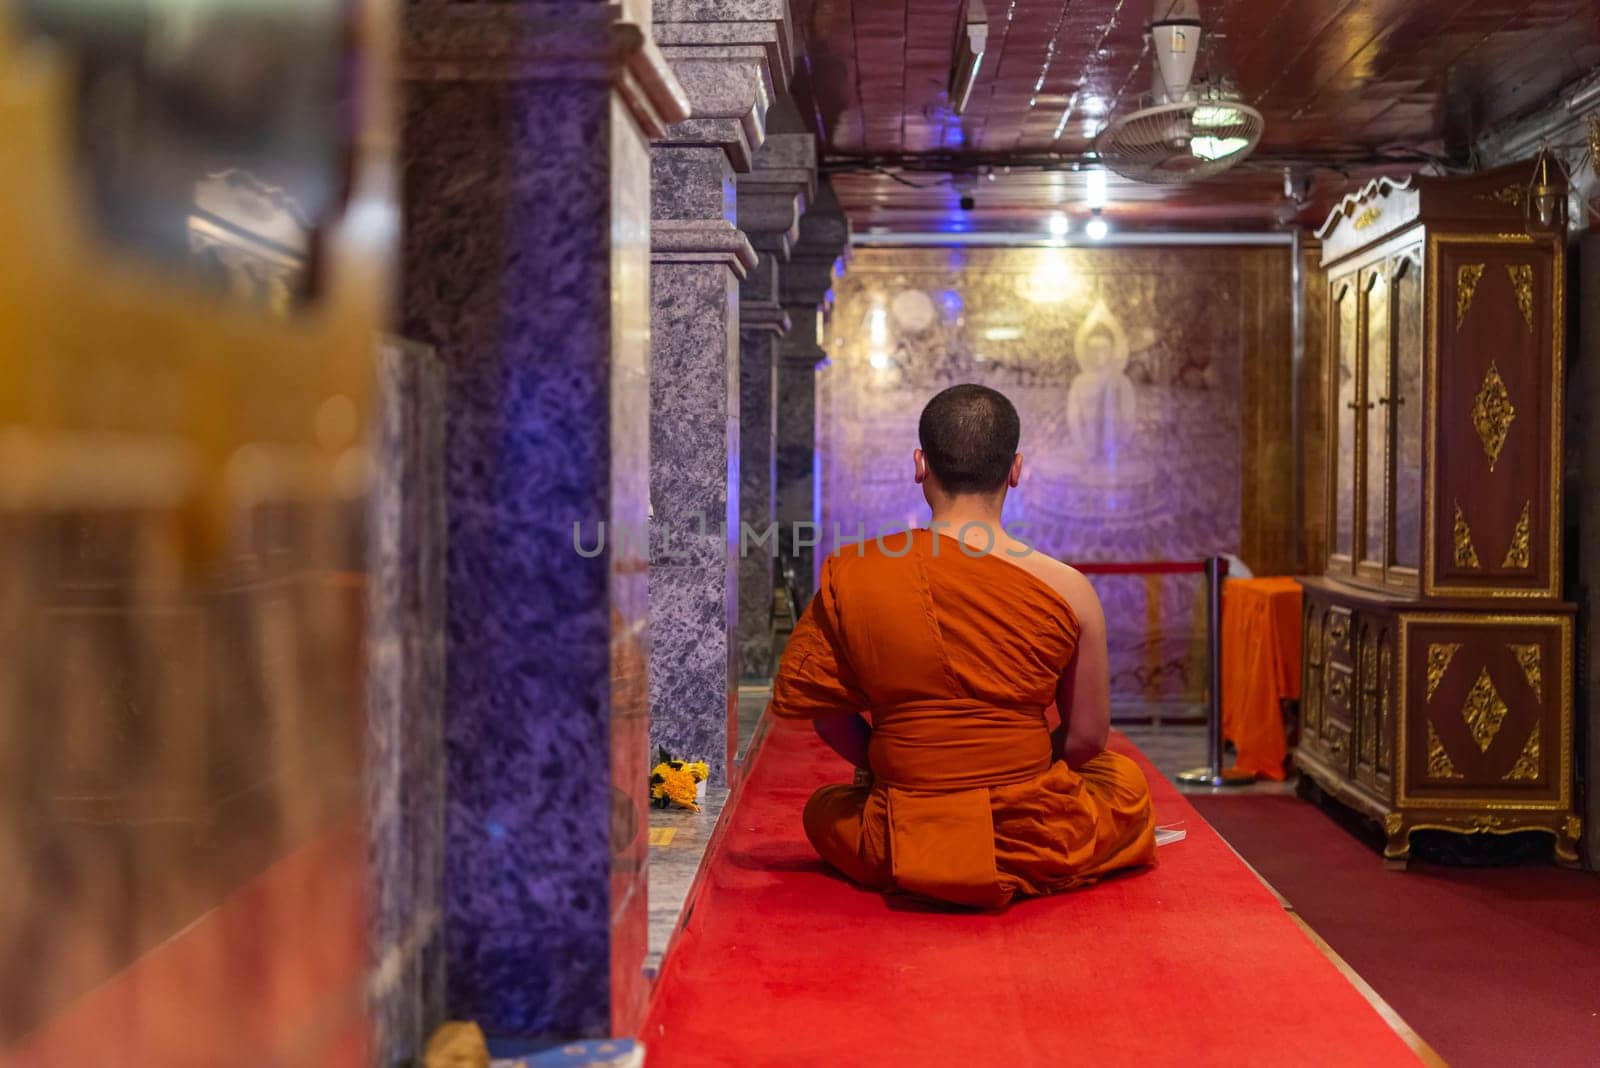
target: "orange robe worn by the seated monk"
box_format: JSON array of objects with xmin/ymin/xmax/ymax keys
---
[{"xmin": 771, "ymin": 531, "xmax": 1155, "ymax": 908}]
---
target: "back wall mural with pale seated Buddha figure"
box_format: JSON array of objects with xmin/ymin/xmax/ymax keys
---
[{"xmin": 818, "ymin": 248, "xmax": 1259, "ymax": 702}]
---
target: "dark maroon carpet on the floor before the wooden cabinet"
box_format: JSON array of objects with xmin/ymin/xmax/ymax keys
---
[{"xmin": 1197, "ymin": 795, "xmax": 1600, "ymax": 1068}]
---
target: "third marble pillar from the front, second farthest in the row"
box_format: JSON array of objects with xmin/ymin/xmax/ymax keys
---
[{"xmin": 738, "ymin": 115, "xmax": 816, "ymax": 684}]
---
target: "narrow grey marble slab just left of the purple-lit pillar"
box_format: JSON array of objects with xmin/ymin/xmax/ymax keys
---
[{"xmin": 366, "ymin": 341, "xmax": 446, "ymax": 1066}]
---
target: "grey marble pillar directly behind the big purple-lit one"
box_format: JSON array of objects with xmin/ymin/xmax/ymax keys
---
[{"xmin": 650, "ymin": 0, "xmax": 792, "ymax": 785}]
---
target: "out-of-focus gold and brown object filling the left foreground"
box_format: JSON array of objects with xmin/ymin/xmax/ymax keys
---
[{"xmin": 0, "ymin": 0, "xmax": 395, "ymax": 1065}]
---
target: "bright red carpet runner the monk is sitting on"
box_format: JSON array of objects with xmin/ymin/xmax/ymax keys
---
[{"xmin": 642, "ymin": 723, "xmax": 1416, "ymax": 1068}]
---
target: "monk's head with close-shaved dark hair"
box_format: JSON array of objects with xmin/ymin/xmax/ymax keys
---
[{"xmin": 917, "ymin": 384, "xmax": 1022, "ymax": 494}]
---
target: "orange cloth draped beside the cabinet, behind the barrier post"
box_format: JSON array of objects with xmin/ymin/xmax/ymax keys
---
[{"xmin": 1222, "ymin": 579, "xmax": 1301, "ymax": 779}]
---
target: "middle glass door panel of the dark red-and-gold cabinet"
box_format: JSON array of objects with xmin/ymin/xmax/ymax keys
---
[{"xmin": 1354, "ymin": 271, "xmax": 1392, "ymax": 579}]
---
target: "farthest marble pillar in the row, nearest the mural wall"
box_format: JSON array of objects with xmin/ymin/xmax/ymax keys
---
[{"xmin": 778, "ymin": 182, "xmax": 850, "ymax": 608}]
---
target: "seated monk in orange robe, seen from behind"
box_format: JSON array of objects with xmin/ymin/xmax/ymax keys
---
[{"xmin": 771, "ymin": 385, "xmax": 1155, "ymax": 908}]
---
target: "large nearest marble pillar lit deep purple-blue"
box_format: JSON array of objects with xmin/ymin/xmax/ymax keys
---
[{"xmin": 402, "ymin": 0, "xmax": 688, "ymax": 1038}]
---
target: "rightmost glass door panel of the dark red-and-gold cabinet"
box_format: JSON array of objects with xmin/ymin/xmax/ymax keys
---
[{"xmin": 1387, "ymin": 248, "xmax": 1422, "ymax": 587}]
